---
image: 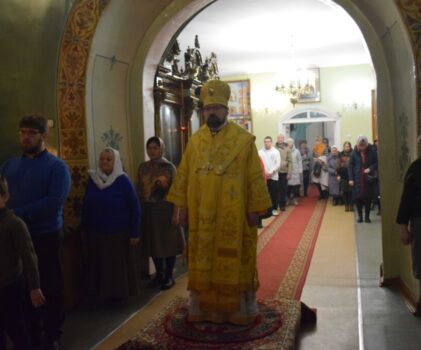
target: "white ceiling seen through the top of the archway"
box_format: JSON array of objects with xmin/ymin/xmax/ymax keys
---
[{"xmin": 178, "ymin": 0, "xmax": 371, "ymax": 76}]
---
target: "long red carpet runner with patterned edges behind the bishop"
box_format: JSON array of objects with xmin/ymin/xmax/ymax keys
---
[{"xmin": 257, "ymin": 190, "xmax": 326, "ymax": 300}]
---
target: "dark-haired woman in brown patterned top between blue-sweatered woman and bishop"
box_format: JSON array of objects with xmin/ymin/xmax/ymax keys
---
[{"xmin": 138, "ymin": 136, "xmax": 185, "ymax": 290}]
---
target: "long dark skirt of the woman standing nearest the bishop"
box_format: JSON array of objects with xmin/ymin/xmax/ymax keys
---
[{"xmin": 142, "ymin": 202, "xmax": 185, "ymax": 258}]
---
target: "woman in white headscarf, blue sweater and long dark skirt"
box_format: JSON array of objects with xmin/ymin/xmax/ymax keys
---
[{"xmin": 81, "ymin": 147, "xmax": 141, "ymax": 302}]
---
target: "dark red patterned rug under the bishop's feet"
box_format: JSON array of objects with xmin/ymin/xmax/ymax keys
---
[{"xmin": 118, "ymin": 297, "xmax": 301, "ymax": 350}]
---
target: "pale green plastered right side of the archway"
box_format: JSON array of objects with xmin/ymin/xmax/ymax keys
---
[{"xmin": 337, "ymin": 0, "xmax": 420, "ymax": 297}]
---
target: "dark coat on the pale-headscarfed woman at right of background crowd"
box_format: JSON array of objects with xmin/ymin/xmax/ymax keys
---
[{"xmin": 348, "ymin": 144, "xmax": 378, "ymax": 199}]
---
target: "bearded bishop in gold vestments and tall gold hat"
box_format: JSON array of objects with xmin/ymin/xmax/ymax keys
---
[{"xmin": 167, "ymin": 80, "xmax": 271, "ymax": 324}]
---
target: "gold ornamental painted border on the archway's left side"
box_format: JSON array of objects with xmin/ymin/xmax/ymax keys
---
[{"xmin": 57, "ymin": 0, "xmax": 110, "ymax": 228}]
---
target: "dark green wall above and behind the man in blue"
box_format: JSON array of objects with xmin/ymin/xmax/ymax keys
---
[{"xmin": 0, "ymin": 0, "xmax": 71, "ymax": 164}]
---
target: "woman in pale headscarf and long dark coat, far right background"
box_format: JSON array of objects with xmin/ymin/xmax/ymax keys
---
[{"xmin": 348, "ymin": 135, "xmax": 378, "ymax": 223}]
